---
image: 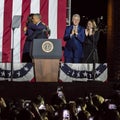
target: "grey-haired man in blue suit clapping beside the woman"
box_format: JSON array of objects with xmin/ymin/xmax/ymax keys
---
[{"xmin": 64, "ymin": 14, "xmax": 85, "ymax": 63}]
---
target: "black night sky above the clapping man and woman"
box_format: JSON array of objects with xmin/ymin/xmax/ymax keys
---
[{"xmin": 71, "ymin": 0, "xmax": 107, "ymax": 24}]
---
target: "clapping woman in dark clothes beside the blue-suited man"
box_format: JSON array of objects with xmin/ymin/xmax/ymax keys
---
[{"xmin": 83, "ymin": 20, "xmax": 100, "ymax": 63}]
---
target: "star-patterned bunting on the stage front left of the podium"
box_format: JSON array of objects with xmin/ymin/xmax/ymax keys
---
[{"xmin": 0, "ymin": 63, "xmax": 34, "ymax": 82}]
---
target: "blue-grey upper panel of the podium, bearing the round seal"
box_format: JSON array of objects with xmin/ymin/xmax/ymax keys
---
[{"xmin": 31, "ymin": 39, "xmax": 62, "ymax": 59}]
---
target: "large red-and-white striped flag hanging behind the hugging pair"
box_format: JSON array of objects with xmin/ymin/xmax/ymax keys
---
[{"xmin": 0, "ymin": 0, "xmax": 66, "ymax": 62}]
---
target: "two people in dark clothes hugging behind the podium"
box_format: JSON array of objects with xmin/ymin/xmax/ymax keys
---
[{"xmin": 22, "ymin": 14, "xmax": 50, "ymax": 62}]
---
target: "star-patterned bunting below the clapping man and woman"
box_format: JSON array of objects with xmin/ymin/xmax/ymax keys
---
[{"xmin": 59, "ymin": 63, "xmax": 108, "ymax": 82}]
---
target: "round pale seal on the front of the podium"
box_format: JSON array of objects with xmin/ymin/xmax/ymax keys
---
[{"xmin": 42, "ymin": 41, "xmax": 54, "ymax": 53}]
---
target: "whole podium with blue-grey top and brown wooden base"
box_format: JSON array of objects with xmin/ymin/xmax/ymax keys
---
[{"xmin": 31, "ymin": 39, "xmax": 62, "ymax": 82}]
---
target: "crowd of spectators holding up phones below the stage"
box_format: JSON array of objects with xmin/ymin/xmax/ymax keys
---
[{"xmin": 0, "ymin": 87, "xmax": 120, "ymax": 120}]
